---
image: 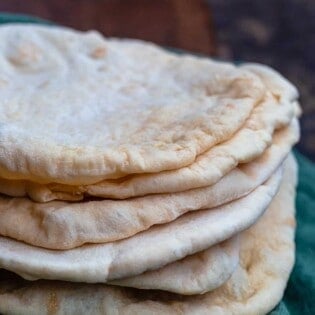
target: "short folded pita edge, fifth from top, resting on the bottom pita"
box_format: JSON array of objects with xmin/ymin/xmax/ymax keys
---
[{"xmin": 110, "ymin": 235, "xmax": 239, "ymax": 295}]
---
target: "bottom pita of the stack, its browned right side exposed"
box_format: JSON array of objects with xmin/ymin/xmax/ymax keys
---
[{"xmin": 0, "ymin": 154, "xmax": 296, "ymax": 315}]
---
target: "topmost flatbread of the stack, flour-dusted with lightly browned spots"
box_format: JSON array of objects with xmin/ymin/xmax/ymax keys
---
[{"xmin": 0, "ymin": 24, "xmax": 265, "ymax": 185}]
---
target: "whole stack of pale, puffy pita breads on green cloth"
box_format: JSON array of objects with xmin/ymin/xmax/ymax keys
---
[{"xmin": 0, "ymin": 24, "xmax": 300, "ymax": 314}]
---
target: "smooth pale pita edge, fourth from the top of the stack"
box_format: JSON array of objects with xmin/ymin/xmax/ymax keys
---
[{"xmin": 0, "ymin": 169, "xmax": 281, "ymax": 283}]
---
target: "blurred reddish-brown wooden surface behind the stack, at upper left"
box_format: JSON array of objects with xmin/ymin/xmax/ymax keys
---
[{"xmin": 0, "ymin": 0, "xmax": 215, "ymax": 54}]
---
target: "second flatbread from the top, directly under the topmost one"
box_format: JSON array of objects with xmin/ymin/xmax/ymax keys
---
[{"xmin": 0, "ymin": 64, "xmax": 299, "ymax": 202}]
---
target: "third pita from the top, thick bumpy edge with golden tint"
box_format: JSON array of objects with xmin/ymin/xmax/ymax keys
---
[{"xmin": 0, "ymin": 122, "xmax": 298, "ymax": 249}]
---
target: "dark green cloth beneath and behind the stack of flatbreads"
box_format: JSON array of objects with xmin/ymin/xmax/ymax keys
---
[{"xmin": 0, "ymin": 13, "xmax": 315, "ymax": 315}]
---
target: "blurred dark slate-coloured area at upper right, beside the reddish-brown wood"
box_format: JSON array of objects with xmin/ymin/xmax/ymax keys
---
[{"xmin": 207, "ymin": 0, "xmax": 315, "ymax": 162}]
